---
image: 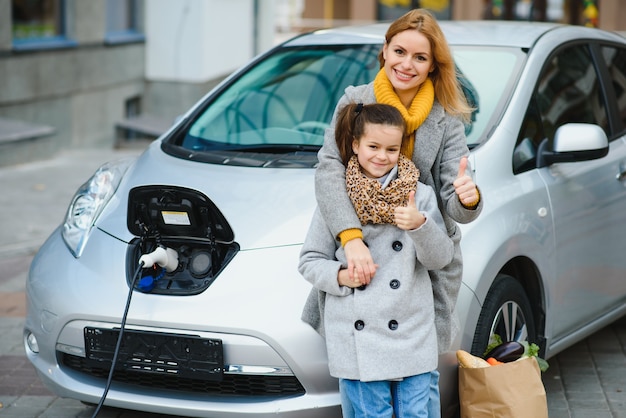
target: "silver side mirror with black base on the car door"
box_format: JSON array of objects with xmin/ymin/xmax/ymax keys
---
[{"xmin": 537, "ymin": 123, "xmax": 609, "ymax": 168}]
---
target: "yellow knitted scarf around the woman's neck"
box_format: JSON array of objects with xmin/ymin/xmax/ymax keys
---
[{"xmin": 374, "ymin": 68, "xmax": 435, "ymax": 159}]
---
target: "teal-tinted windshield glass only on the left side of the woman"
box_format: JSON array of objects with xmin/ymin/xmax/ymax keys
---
[{"xmin": 182, "ymin": 45, "xmax": 380, "ymax": 151}]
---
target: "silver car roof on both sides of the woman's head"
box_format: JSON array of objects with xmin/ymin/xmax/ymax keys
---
[{"xmin": 285, "ymin": 20, "xmax": 624, "ymax": 48}]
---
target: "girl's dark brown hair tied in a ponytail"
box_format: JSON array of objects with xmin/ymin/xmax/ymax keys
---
[{"xmin": 335, "ymin": 103, "xmax": 406, "ymax": 165}]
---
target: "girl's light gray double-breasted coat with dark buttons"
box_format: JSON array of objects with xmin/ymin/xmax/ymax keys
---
[{"xmin": 299, "ymin": 184, "xmax": 454, "ymax": 382}]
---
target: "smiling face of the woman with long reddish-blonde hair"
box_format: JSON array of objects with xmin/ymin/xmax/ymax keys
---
[{"xmin": 383, "ymin": 29, "xmax": 435, "ymax": 108}]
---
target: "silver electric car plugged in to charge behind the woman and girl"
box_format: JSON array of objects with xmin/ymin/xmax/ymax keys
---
[{"xmin": 24, "ymin": 21, "xmax": 626, "ymax": 418}]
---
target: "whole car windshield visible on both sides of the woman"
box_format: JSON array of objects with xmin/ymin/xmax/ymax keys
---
[{"xmin": 164, "ymin": 44, "xmax": 523, "ymax": 166}]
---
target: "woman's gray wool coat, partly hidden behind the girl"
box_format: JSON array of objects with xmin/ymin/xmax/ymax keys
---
[{"xmin": 302, "ymin": 83, "xmax": 483, "ymax": 352}]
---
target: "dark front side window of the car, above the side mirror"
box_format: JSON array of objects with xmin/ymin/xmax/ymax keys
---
[{"xmin": 513, "ymin": 45, "xmax": 610, "ymax": 173}]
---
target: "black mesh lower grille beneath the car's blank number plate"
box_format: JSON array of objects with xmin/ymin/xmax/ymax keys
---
[{"xmin": 58, "ymin": 352, "xmax": 304, "ymax": 397}]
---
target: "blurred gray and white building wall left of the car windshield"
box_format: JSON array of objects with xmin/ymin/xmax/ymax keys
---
[{"xmin": 0, "ymin": 0, "xmax": 274, "ymax": 166}]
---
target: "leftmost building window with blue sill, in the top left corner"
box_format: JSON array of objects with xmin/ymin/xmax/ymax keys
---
[{"xmin": 11, "ymin": 0, "xmax": 73, "ymax": 49}]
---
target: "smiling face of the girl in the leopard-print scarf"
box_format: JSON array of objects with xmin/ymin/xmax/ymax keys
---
[{"xmin": 352, "ymin": 123, "xmax": 404, "ymax": 179}]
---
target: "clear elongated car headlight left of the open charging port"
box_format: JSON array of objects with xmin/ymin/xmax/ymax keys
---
[{"xmin": 63, "ymin": 157, "xmax": 135, "ymax": 258}]
